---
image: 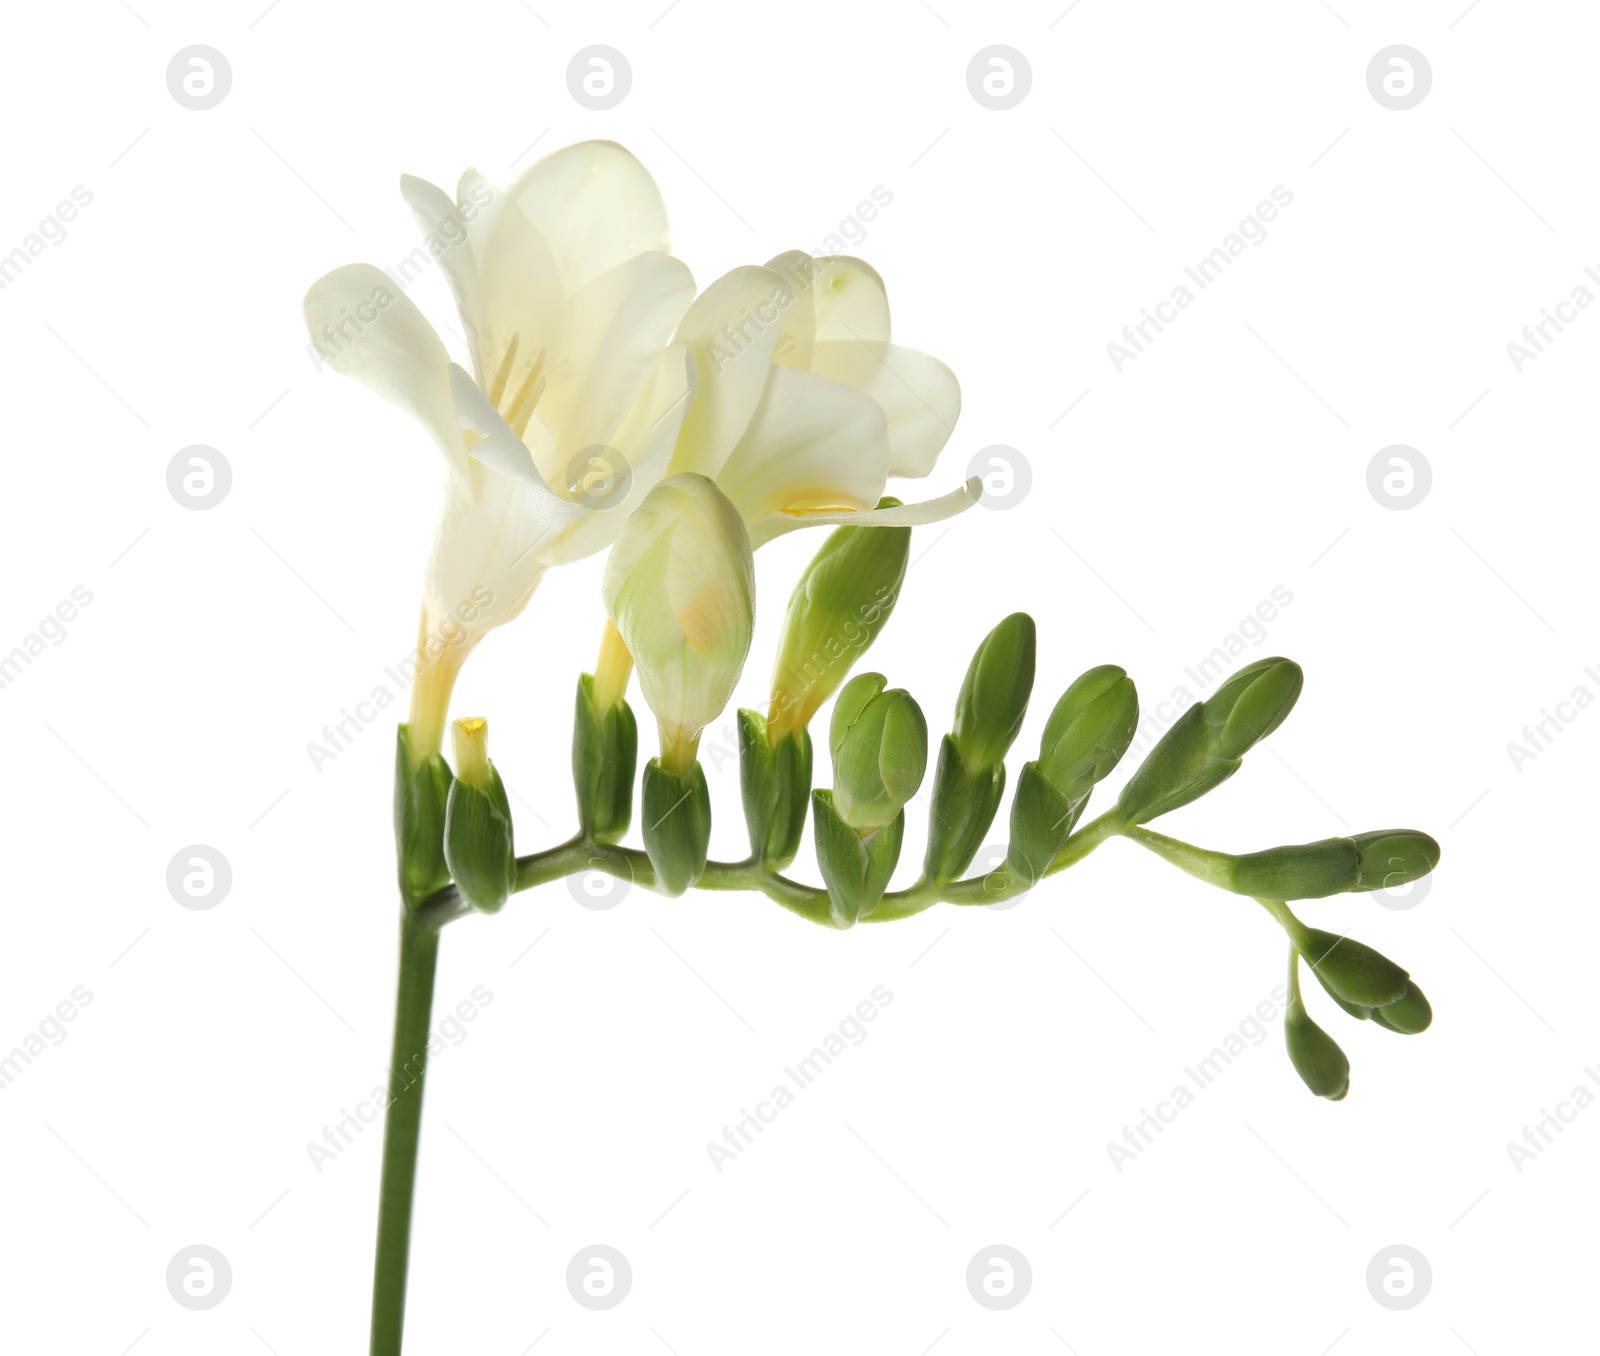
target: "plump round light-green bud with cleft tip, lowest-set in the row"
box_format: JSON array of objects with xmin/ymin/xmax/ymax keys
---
[{"xmin": 827, "ymin": 673, "xmax": 928, "ymax": 838}]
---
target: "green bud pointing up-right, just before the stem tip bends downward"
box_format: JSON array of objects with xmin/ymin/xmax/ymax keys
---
[{"xmin": 1117, "ymin": 659, "xmax": 1304, "ymax": 824}]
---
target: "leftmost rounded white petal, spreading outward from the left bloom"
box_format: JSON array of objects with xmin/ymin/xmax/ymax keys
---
[{"xmin": 306, "ymin": 264, "xmax": 464, "ymax": 470}]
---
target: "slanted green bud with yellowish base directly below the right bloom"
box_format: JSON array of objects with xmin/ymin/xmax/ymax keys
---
[{"xmin": 768, "ymin": 499, "xmax": 910, "ymax": 741}]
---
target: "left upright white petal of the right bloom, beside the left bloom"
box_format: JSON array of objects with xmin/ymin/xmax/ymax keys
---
[{"xmin": 672, "ymin": 265, "xmax": 794, "ymax": 477}]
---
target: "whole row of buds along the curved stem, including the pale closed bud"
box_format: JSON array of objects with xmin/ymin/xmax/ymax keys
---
[{"xmin": 395, "ymin": 486, "xmax": 1438, "ymax": 1100}]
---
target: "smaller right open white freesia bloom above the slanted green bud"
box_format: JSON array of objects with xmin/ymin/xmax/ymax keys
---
[{"xmin": 670, "ymin": 251, "xmax": 981, "ymax": 547}]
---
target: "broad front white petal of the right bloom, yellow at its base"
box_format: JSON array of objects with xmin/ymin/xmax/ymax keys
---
[{"xmin": 717, "ymin": 365, "xmax": 890, "ymax": 545}]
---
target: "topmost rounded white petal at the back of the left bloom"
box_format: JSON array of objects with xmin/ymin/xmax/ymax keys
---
[{"xmin": 510, "ymin": 141, "xmax": 669, "ymax": 291}]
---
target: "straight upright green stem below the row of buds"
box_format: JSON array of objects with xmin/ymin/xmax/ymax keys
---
[{"xmin": 371, "ymin": 911, "xmax": 438, "ymax": 1356}]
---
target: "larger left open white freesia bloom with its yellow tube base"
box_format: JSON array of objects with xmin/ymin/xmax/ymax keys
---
[{"xmin": 306, "ymin": 141, "xmax": 694, "ymax": 756}]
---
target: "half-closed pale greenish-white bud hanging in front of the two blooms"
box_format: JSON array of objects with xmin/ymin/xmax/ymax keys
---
[{"xmin": 602, "ymin": 475, "xmax": 755, "ymax": 776}]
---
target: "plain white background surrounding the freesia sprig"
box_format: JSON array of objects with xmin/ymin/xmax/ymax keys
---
[{"xmin": 0, "ymin": 0, "xmax": 1600, "ymax": 1356}]
